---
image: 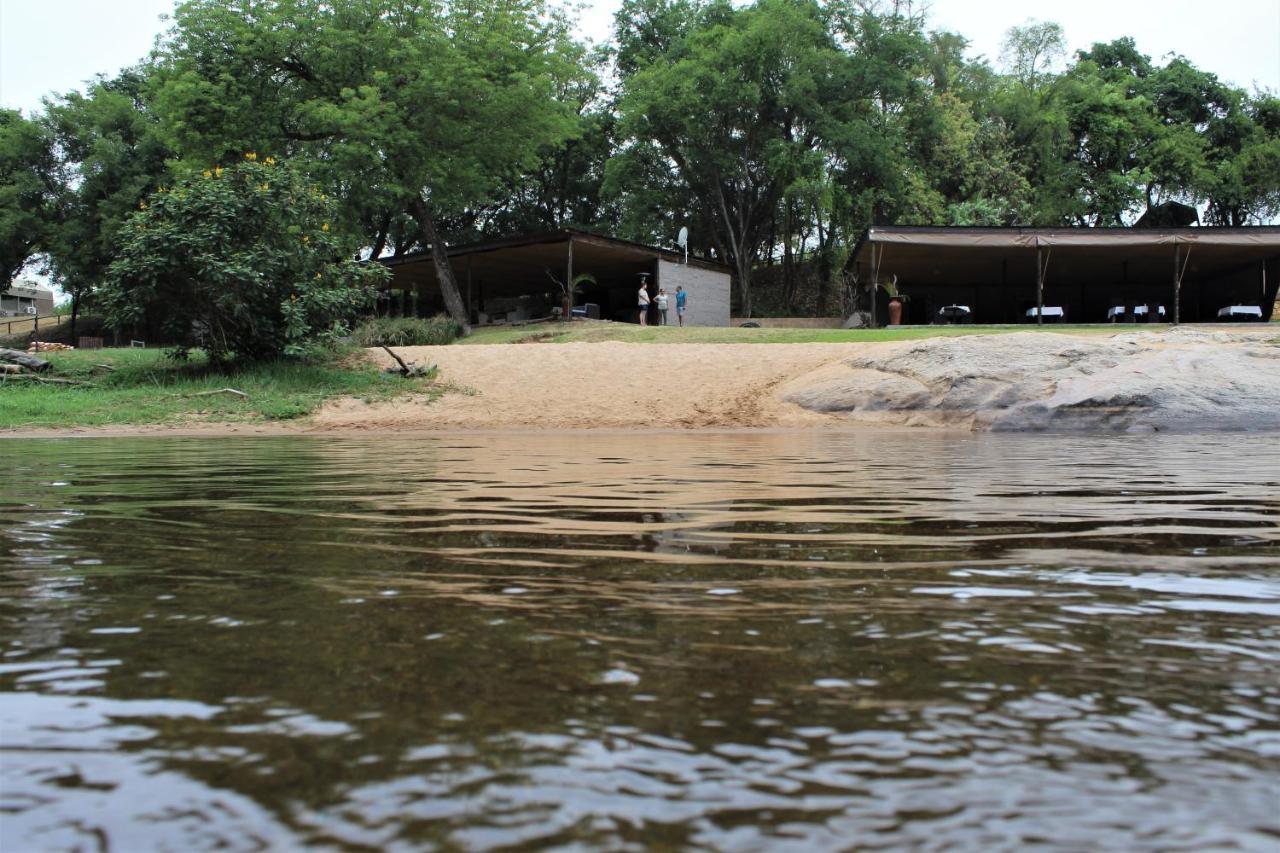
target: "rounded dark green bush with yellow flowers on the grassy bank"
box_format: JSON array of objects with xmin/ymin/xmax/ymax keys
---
[{"xmin": 100, "ymin": 154, "xmax": 389, "ymax": 361}]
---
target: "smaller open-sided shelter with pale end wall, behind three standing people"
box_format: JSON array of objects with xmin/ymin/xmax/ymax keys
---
[{"xmin": 383, "ymin": 231, "xmax": 730, "ymax": 325}]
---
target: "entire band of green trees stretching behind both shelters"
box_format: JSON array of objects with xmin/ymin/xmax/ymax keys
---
[{"xmin": 0, "ymin": 0, "xmax": 1280, "ymax": 325}]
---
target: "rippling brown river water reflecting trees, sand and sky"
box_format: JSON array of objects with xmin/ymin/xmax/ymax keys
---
[{"xmin": 0, "ymin": 432, "xmax": 1280, "ymax": 850}]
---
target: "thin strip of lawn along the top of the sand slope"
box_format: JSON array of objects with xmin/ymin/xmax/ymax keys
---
[{"xmin": 458, "ymin": 323, "xmax": 1165, "ymax": 345}]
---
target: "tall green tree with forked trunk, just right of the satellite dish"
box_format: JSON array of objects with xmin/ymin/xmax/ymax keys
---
[{"xmin": 611, "ymin": 0, "xmax": 847, "ymax": 316}]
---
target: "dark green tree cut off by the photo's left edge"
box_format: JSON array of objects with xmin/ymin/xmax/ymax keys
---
[{"xmin": 0, "ymin": 110, "xmax": 61, "ymax": 280}]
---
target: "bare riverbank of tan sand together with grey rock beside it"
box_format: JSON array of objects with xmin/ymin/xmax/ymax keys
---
[{"xmin": 310, "ymin": 327, "xmax": 1280, "ymax": 430}]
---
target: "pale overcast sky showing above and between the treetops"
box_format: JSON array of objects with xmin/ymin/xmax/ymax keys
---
[{"xmin": 0, "ymin": 0, "xmax": 1280, "ymax": 110}]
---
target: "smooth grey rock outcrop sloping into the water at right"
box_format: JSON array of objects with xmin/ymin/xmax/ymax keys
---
[{"xmin": 782, "ymin": 328, "xmax": 1280, "ymax": 432}]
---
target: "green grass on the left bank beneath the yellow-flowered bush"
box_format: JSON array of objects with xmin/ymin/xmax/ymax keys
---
[{"xmin": 0, "ymin": 350, "xmax": 438, "ymax": 429}]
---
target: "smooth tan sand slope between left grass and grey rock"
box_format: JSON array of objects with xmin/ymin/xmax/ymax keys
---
[{"xmin": 314, "ymin": 342, "xmax": 868, "ymax": 429}]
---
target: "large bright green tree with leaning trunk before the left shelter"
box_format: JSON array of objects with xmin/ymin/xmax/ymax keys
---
[{"xmin": 149, "ymin": 0, "xmax": 581, "ymax": 330}]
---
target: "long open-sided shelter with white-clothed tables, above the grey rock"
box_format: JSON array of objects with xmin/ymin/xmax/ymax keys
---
[{"xmin": 851, "ymin": 227, "xmax": 1280, "ymax": 323}]
